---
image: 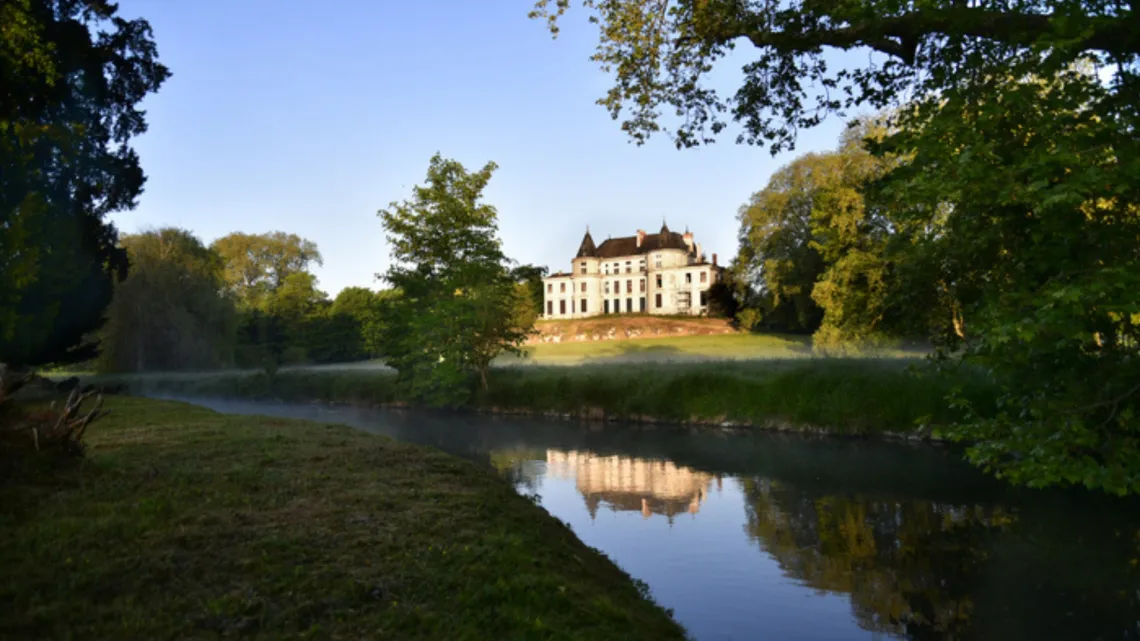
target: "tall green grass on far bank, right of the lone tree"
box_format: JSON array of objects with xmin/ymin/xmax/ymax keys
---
[{"xmin": 480, "ymin": 358, "xmax": 991, "ymax": 433}]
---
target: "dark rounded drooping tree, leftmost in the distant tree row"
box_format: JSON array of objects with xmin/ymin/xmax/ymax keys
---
[{"xmin": 97, "ymin": 228, "xmax": 237, "ymax": 372}]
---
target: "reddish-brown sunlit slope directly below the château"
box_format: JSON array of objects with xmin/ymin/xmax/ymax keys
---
[{"xmin": 527, "ymin": 315, "xmax": 736, "ymax": 344}]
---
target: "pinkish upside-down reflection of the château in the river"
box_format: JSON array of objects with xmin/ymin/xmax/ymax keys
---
[{"xmin": 546, "ymin": 449, "xmax": 720, "ymax": 522}]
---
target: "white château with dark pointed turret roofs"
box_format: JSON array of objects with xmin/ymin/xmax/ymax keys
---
[{"xmin": 543, "ymin": 224, "xmax": 723, "ymax": 318}]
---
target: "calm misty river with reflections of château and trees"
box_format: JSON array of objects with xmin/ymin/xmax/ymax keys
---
[{"xmin": 168, "ymin": 399, "xmax": 1140, "ymax": 641}]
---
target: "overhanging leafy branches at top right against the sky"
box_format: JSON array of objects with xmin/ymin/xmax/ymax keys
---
[{"xmin": 531, "ymin": 0, "xmax": 1140, "ymax": 153}]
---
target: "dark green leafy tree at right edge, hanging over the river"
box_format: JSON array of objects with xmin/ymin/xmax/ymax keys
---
[{"xmin": 884, "ymin": 68, "xmax": 1140, "ymax": 493}]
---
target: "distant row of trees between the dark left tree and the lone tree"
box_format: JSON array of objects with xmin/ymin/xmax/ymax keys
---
[{"xmin": 93, "ymin": 228, "xmax": 398, "ymax": 372}]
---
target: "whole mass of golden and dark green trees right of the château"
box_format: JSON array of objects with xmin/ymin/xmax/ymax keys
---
[{"xmin": 732, "ymin": 65, "xmax": 1140, "ymax": 493}]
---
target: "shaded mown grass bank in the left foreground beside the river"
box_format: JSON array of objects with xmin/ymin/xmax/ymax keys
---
[{"xmin": 0, "ymin": 398, "xmax": 683, "ymax": 640}]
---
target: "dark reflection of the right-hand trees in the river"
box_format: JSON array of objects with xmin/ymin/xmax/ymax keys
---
[{"xmin": 742, "ymin": 478, "xmax": 1140, "ymax": 640}]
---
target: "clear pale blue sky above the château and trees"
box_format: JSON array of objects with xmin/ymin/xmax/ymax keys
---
[{"xmin": 114, "ymin": 0, "xmax": 857, "ymax": 295}]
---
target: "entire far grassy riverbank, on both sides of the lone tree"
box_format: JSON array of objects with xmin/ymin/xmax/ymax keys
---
[{"xmin": 93, "ymin": 358, "xmax": 990, "ymax": 433}]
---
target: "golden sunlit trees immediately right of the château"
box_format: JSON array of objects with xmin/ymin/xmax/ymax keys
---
[{"xmin": 731, "ymin": 119, "xmax": 916, "ymax": 342}]
